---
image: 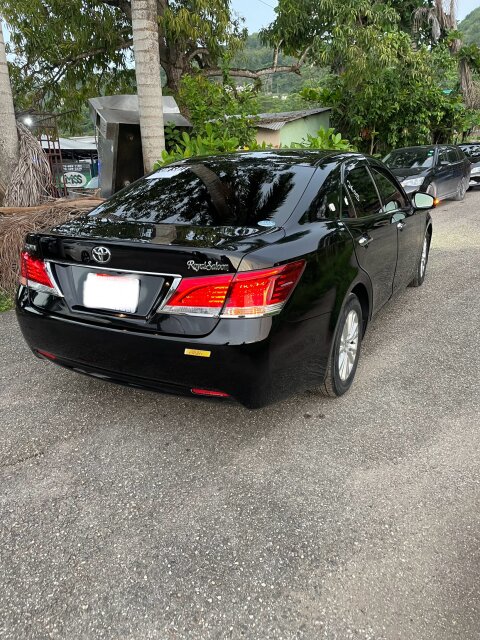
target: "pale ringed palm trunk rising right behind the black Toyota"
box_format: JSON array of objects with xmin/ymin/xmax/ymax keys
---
[{"xmin": 131, "ymin": 0, "xmax": 165, "ymax": 173}]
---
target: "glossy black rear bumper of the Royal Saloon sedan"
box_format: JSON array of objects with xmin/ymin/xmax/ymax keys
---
[{"xmin": 17, "ymin": 299, "xmax": 330, "ymax": 408}]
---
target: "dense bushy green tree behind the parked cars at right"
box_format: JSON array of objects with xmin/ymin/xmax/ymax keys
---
[{"xmin": 303, "ymin": 42, "xmax": 472, "ymax": 154}]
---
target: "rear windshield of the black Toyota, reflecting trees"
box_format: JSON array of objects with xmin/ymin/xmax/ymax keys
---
[{"xmin": 90, "ymin": 154, "xmax": 315, "ymax": 227}]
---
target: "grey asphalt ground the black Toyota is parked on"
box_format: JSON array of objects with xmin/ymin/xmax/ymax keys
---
[{"xmin": 0, "ymin": 192, "xmax": 480, "ymax": 640}]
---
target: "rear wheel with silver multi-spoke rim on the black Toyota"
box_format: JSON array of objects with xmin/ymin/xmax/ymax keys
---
[{"xmin": 320, "ymin": 293, "xmax": 363, "ymax": 398}]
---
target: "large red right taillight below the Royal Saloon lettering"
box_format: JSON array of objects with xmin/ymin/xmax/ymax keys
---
[{"xmin": 161, "ymin": 260, "xmax": 305, "ymax": 318}]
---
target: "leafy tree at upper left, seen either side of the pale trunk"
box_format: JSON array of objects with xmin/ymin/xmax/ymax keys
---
[{"xmin": 0, "ymin": 0, "xmax": 312, "ymax": 127}]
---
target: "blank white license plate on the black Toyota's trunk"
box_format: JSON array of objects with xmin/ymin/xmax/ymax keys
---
[{"xmin": 83, "ymin": 273, "xmax": 140, "ymax": 313}]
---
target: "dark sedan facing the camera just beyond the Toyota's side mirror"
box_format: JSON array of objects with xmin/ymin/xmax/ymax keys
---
[{"xmin": 383, "ymin": 145, "xmax": 470, "ymax": 200}]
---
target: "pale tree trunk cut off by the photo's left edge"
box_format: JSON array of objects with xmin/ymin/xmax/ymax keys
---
[{"xmin": 0, "ymin": 18, "xmax": 18, "ymax": 205}]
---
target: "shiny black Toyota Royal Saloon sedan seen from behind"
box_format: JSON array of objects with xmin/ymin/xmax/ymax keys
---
[{"xmin": 17, "ymin": 150, "xmax": 434, "ymax": 408}]
